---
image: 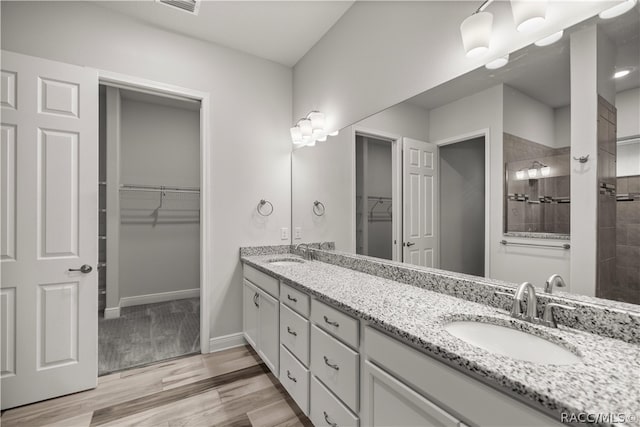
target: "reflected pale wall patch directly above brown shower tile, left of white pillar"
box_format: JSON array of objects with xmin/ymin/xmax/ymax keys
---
[{"xmin": 504, "ymin": 85, "xmax": 556, "ymax": 147}]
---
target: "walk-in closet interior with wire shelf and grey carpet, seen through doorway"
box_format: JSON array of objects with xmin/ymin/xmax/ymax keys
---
[{"xmin": 98, "ymin": 85, "xmax": 200, "ymax": 375}]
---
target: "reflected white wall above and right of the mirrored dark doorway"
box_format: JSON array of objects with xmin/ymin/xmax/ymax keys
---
[{"xmin": 429, "ymin": 85, "xmax": 570, "ymax": 286}]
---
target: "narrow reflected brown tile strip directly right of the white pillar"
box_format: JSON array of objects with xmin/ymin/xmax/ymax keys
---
[{"xmin": 596, "ymin": 96, "xmax": 617, "ymax": 299}]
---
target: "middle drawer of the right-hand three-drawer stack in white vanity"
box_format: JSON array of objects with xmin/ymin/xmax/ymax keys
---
[{"xmin": 311, "ymin": 325, "xmax": 360, "ymax": 412}]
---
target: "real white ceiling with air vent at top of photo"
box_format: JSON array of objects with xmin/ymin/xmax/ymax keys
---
[{"xmin": 94, "ymin": 0, "xmax": 353, "ymax": 67}]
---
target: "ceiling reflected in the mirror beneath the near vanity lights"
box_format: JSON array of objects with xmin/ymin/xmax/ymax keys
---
[{"xmin": 407, "ymin": 5, "xmax": 640, "ymax": 110}]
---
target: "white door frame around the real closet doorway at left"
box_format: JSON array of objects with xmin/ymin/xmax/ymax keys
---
[{"xmin": 96, "ymin": 70, "xmax": 214, "ymax": 354}]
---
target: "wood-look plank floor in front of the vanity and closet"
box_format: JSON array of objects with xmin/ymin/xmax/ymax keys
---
[{"xmin": 0, "ymin": 347, "xmax": 312, "ymax": 427}]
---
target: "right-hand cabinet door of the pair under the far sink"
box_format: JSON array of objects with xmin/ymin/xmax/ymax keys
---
[{"xmin": 258, "ymin": 290, "xmax": 280, "ymax": 377}]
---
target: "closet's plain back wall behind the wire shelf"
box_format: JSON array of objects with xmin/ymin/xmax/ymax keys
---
[{"xmin": 119, "ymin": 98, "xmax": 200, "ymax": 298}]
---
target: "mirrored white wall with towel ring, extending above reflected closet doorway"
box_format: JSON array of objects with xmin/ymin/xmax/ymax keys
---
[{"xmin": 291, "ymin": 103, "xmax": 429, "ymax": 253}]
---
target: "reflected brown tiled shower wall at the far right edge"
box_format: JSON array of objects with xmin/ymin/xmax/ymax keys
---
[{"xmin": 609, "ymin": 175, "xmax": 640, "ymax": 304}]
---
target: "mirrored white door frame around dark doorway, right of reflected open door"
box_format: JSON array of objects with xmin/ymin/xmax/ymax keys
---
[{"xmin": 434, "ymin": 128, "xmax": 491, "ymax": 277}]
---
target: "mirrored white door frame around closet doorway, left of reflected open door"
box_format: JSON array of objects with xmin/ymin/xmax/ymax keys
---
[{"xmin": 349, "ymin": 125, "xmax": 402, "ymax": 262}]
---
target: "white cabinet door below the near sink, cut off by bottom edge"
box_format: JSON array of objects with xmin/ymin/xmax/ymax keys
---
[{"xmin": 362, "ymin": 361, "xmax": 462, "ymax": 427}]
